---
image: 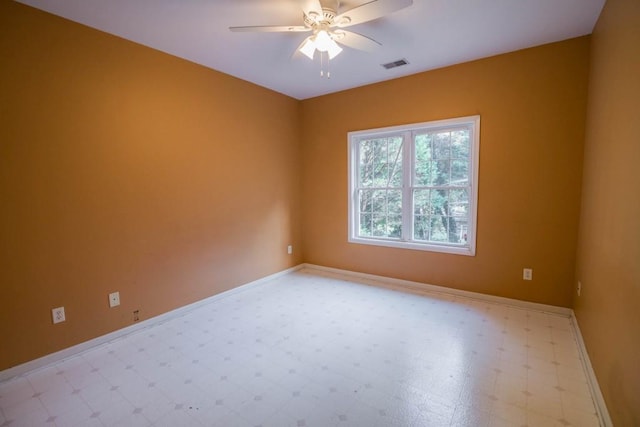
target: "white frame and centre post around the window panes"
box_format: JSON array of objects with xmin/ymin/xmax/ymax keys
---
[{"xmin": 347, "ymin": 115, "xmax": 480, "ymax": 256}]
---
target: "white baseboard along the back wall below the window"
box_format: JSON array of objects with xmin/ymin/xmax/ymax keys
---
[{"xmin": 302, "ymin": 264, "xmax": 573, "ymax": 317}]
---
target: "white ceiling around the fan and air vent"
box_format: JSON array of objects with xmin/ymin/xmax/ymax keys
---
[{"xmin": 19, "ymin": 0, "xmax": 605, "ymax": 99}]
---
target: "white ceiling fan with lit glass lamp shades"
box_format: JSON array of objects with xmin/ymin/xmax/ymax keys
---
[{"xmin": 229, "ymin": 0, "xmax": 413, "ymax": 59}]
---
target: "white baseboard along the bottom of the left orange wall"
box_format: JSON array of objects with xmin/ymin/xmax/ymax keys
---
[{"xmin": 0, "ymin": 265, "xmax": 302, "ymax": 382}]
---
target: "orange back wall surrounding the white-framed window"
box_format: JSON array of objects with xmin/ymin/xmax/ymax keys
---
[{"xmin": 302, "ymin": 37, "xmax": 589, "ymax": 307}]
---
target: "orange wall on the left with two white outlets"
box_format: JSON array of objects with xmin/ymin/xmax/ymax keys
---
[{"xmin": 0, "ymin": 1, "xmax": 302, "ymax": 370}]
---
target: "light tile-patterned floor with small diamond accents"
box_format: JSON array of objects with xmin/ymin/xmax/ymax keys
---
[{"xmin": 0, "ymin": 272, "xmax": 599, "ymax": 427}]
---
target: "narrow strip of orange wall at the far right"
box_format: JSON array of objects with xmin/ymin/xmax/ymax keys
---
[{"xmin": 575, "ymin": 0, "xmax": 640, "ymax": 426}]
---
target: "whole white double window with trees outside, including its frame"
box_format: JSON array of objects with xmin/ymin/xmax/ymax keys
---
[{"xmin": 349, "ymin": 116, "xmax": 480, "ymax": 255}]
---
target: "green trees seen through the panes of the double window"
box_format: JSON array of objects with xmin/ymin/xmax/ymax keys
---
[{"xmin": 358, "ymin": 128, "xmax": 470, "ymax": 243}]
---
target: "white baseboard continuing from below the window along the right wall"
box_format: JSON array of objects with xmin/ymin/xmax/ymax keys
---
[{"xmin": 301, "ymin": 264, "xmax": 613, "ymax": 427}]
